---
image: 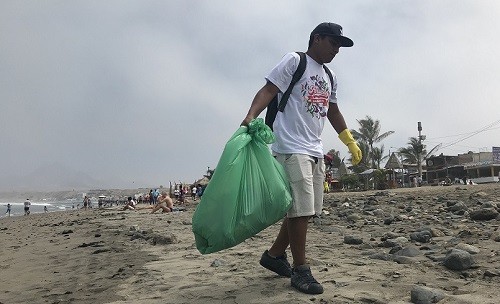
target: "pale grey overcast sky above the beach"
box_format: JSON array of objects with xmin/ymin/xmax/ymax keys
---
[{"xmin": 0, "ymin": 0, "xmax": 500, "ymax": 188}]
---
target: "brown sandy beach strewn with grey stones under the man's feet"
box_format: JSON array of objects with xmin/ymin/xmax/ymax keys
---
[{"xmin": 0, "ymin": 184, "xmax": 500, "ymax": 304}]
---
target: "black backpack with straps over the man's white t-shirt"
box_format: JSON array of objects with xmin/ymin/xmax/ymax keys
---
[{"xmin": 265, "ymin": 52, "xmax": 333, "ymax": 130}]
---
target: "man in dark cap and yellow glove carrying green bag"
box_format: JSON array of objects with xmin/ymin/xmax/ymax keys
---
[{"xmin": 242, "ymin": 23, "xmax": 362, "ymax": 294}]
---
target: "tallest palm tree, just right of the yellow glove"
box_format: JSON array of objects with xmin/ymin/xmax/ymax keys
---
[{"xmin": 351, "ymin": 115, "xmax": 394, "ymax": 168}]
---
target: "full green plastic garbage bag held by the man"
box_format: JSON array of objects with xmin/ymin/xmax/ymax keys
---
[{"xmin": 192, "ymin": 118, "xmax": 292, "ymax": 254}]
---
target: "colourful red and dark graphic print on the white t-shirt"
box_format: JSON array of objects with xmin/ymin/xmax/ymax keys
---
[{"xmin": 301, "ymin": 75, "xmax": 330, "ymax": 119}]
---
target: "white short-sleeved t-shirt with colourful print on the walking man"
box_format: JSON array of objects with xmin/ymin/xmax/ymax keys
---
[{"xmin": 266, "ymin": 53, "xmax": 337, "ymax": 158}]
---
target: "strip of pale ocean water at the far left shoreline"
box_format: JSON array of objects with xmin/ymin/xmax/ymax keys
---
[{"xmin": 0, "ymin": 200, "xmax": 79, "ymax": 218}]
